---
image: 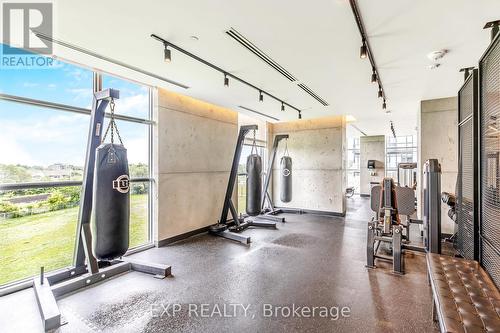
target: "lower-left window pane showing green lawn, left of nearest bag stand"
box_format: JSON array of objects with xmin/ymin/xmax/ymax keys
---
[{"xmin": 0, "ymin": 186, "xmax": 80, "ymax": 285}]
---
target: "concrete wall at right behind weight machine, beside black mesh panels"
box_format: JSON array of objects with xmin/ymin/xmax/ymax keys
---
[{"xmin": 418, "ymin": 97, "xmax": 458, "ymax": 233}]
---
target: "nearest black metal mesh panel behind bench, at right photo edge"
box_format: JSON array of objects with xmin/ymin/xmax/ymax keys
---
[{"xmin": 479, "ymin": 36, "xmax": 500, "ymax": 286}]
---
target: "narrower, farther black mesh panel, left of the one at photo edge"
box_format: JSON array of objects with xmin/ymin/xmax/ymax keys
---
[{"xmin": 455, "ymin": 71, "xmax": 479, "ymax": 259}]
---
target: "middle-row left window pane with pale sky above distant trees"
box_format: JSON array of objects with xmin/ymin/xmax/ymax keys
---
[{"xmin": 0, "ymin": 101, "xmax": 90, "ymax": 183}]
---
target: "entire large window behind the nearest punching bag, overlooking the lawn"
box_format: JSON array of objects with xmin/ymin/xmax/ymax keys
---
[{"xmin": 0, "ymin": 61, "xmax": 152, "ymax": 285}]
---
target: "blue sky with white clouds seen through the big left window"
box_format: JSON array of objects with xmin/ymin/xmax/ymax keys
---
[{"xmin": 0, "ymin": 50, "xmax": 149, "ymax": 166}]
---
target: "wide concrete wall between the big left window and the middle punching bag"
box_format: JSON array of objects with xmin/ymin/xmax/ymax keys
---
[{"xmin": 154, "ymin": 89, "xmax": 238, "ymax": 241}]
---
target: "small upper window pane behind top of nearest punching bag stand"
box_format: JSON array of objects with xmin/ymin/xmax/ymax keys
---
[{"xmin": 102, "ymin": 74, "xmax": 149, "ymax": 119}]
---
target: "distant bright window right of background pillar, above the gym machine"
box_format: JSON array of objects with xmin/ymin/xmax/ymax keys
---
[{"xmin": 385, "ymin": 135, "xmax": 417, "ymax": 180}]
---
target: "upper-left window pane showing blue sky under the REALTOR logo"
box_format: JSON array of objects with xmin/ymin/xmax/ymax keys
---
[{"xmin": 0, "ymin": 60, "xmax": 93, "ymax": 109}]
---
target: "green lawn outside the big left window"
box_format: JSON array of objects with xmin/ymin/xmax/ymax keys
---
[{"xmin": 0, "ymin": 194, "xmax": 148, "ymax": 285}]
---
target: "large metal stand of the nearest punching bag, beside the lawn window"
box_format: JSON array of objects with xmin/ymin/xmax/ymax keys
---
[{"xmin": 33, "ymin": 89, "xmax": 171, "ymax": 331}]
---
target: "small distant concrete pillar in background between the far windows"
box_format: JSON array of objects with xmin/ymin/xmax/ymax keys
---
[{"xmin": 359, "ymin": 135, "xmax": 385, "ymax": 195}]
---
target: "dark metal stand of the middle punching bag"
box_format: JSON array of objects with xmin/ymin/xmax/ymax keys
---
[{"xmin": 208, "ymin": 125, "xmax": 276, "ymax": 244}]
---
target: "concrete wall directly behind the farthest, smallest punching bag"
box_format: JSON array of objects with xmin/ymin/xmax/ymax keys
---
[{"xmin": 269, "ymin": 117, "xmax": 347, "ymax": 214}]
